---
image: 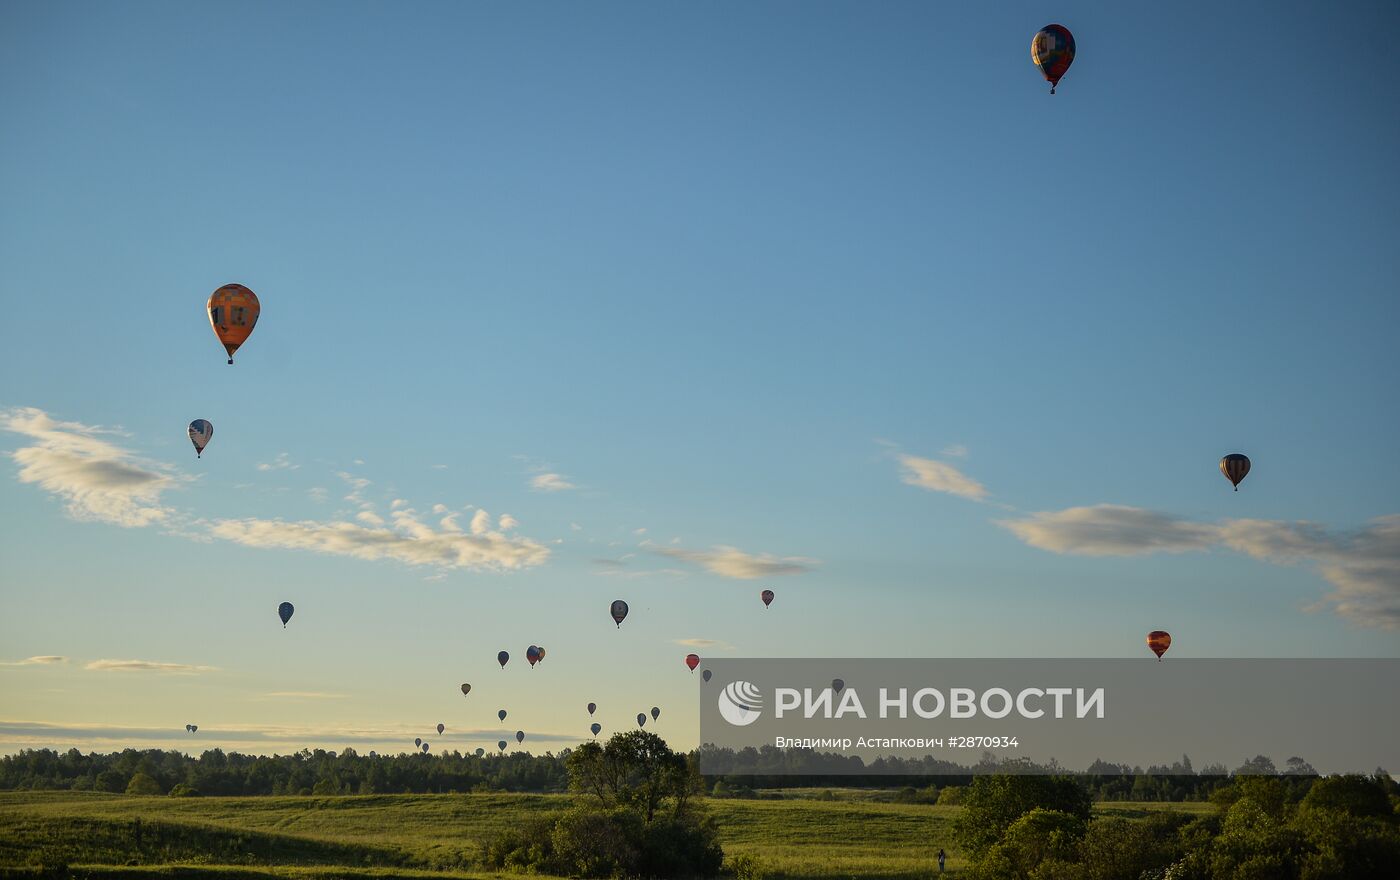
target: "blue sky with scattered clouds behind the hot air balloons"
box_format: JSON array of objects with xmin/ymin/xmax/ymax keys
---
[{"xmin": 0, "ymin": 3, "xmax": 1400, "ymax": 751}]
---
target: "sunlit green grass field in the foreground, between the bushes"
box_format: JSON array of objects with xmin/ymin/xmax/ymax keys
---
[{"xmin": 0, "ymin": 792, "xmax": 1208, "ymax": 880}]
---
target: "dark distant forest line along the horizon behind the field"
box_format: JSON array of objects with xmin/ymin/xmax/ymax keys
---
[{"xmin": 0, "ymin": 747, "xmax": 1386, "ymax": 803}]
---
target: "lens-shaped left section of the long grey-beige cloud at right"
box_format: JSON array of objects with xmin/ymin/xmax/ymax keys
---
[{"xmin": 997, "ymin": 504, "xmax": 1218, "ymax": 555}]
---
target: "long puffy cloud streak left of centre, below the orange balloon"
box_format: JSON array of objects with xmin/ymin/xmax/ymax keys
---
[{"xmin": 209, "ymin": 509, "xmax": 549, "ymax": 569}]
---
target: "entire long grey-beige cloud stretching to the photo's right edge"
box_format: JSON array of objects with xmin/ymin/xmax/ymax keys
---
[{"xmin": 998, "ymin": 504, "xmax": 1400, "ymax": 630}]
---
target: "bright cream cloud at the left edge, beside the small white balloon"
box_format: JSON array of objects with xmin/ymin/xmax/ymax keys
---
[{"xmin": 0, "ymin": 407, "xmax": 176, "ymax": 527}]
